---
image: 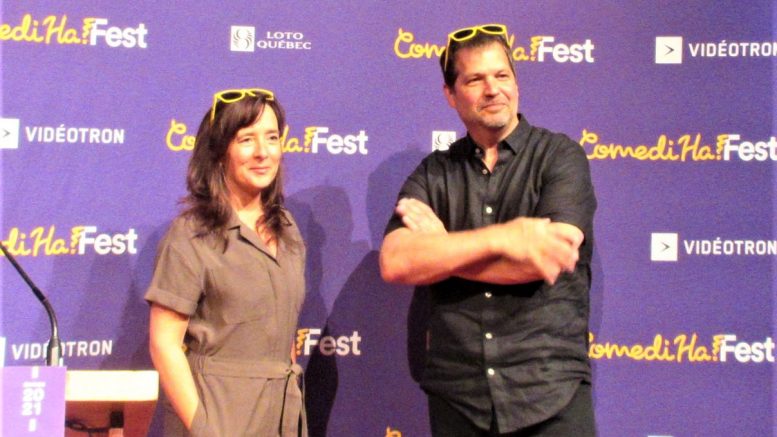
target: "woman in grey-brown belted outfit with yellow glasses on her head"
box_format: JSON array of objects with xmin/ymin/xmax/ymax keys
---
[{"xmin": 145, "ymin": 88, "xmax": 307, "ymax": 437}]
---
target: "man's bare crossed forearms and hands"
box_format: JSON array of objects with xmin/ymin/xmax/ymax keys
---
[{"xmin": 380, "ymin": 198, "xmax": 583, "ymax": 285}]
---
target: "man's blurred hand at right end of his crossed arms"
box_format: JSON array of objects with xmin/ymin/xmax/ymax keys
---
[{"xmin": 494, "ymin": 217, "xmax": 583, "ymax": 284}]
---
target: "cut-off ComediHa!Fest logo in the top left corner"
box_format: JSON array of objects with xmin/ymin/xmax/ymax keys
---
[{"xmin": 0, "ymin": 14, "xmax": 148, "ymax": 49}]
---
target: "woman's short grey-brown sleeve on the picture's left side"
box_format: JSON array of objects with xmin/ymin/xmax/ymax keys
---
[{"xmin": 144, "ymin": 225, "xmax": 203, "ymax": 316}]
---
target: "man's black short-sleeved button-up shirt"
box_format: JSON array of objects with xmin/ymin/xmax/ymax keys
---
[{"xmin": 386, "ymin": 114, "xmax": 596, "ymax": 433}]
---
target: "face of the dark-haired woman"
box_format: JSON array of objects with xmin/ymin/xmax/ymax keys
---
[{"xmin": 226, "ymin": 105, "xmax": 282, "ymax": 198}]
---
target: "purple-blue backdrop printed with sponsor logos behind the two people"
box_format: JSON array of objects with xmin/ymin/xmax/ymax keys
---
[{"xmin": 0, "ymin": 0, "xmax": 777, "ymax": 437}]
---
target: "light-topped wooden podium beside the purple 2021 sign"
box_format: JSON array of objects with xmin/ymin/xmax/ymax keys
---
[{"xmin": 65, "ymin": 370, "xmax": 159, "ymax": 437}]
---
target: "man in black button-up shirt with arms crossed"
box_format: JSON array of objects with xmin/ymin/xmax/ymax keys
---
[{"xmin": 380, "ymin": 24, "xmax": 596, "ymax": 437}]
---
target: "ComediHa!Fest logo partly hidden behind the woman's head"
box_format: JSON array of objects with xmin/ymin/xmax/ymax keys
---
[{"xmin": 165, "ymin": 119, "xmax": 370, "ymax": 155}]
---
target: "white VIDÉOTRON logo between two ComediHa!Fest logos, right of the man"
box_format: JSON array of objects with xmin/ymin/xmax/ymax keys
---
[{"xmin": 650, "ymin": 232, "xmax": 777, "ymax": 262}]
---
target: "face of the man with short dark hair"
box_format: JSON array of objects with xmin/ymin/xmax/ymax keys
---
[{"xmin": 445, "ymin": 42, "xmax": 518, "ymax": 135}]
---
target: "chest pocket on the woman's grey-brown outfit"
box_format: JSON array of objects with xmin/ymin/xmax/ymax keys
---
[{"xmin": 203, "ymin": 261, "xmax": 275, "ymax": 324}]
